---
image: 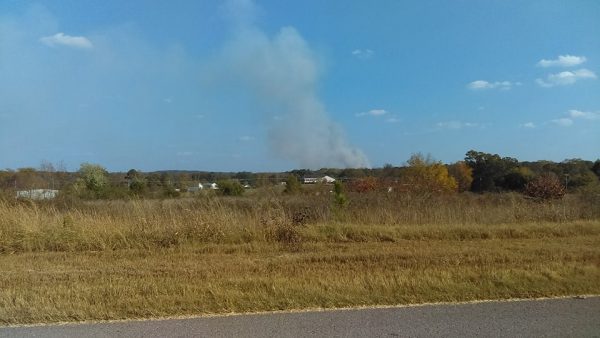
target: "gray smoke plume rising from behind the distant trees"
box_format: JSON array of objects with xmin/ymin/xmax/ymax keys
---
[{"xmin": 213, "ymin": 1, "xmax": 369, "ymax": 168}]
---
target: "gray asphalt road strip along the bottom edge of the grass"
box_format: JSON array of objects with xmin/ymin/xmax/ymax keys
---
[{"xmin": 0, "ymin": 297, "xmax": 600, "ymax": 337}]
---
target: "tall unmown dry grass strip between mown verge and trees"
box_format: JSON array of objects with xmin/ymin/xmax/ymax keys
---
[{"xmin": 0, "ymin": 194, "xmax": 600, "ymax": 252}]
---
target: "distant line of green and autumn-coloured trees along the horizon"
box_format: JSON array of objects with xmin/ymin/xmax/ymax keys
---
[{"xmin": 0, "ymin": 150, "xmax": 600, "ymax": 199}]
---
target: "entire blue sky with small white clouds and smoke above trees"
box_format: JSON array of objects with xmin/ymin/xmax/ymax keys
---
[{"xmin": 0, "ymin": 0, "xmax": 600, "ymax": 171}]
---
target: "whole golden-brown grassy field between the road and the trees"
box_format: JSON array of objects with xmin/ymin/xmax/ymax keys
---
[{"xmin": 0, "ymin": 194, "xmax": 600, "ymax": 325}]
